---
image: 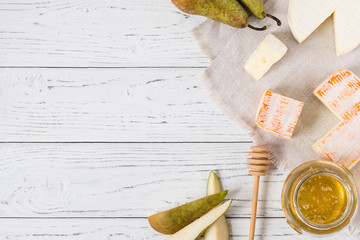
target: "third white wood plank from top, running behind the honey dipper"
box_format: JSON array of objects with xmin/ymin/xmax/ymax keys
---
[{"xmin": 0, "ymin": 143, "xmax": 285, "ymax": 217}]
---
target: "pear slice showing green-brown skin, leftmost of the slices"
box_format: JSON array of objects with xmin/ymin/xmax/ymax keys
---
[{"xmin": 148, "ymin": 191, "xmax": 227, "ymax": 234}]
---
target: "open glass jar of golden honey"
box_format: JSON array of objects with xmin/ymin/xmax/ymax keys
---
[{"xmin": 281, "ymin": 160, "xmax": 358, "ymax": 235}]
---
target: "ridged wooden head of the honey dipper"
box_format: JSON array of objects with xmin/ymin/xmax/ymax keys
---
[{"xmin": 247, "ymin": 146, "xmax": 271, "ymax": 176}]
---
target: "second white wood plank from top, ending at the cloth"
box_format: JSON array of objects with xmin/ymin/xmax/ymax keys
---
[{"xmin": 0, "ymin": 69, "xmax": 250, "ymax": 142}]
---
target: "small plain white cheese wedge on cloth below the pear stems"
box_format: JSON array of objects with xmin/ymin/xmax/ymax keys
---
[{"xmin": 244, "ymin": 34, "xmax": 287, "ymax": 80}]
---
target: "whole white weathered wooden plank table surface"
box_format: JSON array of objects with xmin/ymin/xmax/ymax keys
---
[{"xmin": 0, "ymin": 0, "xmax": 350, "ymax": 240}]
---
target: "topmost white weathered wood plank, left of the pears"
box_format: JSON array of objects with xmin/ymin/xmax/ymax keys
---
[{"xmin": 0, "ymin": 0, "xmax": 209, "ymax": 67}]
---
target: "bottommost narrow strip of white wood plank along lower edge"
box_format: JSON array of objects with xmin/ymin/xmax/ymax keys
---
[{"xmin": 0, "ymin": 218, "xmax": 352, "ymax": 240}]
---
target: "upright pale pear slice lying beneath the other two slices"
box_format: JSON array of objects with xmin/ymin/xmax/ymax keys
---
[{"xmin": 204, "ymin": 171, "xmax": 230, "ymax": 240}]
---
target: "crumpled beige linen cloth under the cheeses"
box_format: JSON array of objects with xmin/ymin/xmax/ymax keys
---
[{"xmin": 193, "ymin": 0, "xmax": 360, "ymax": 239}]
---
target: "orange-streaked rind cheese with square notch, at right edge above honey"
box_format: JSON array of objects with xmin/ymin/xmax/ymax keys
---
[{"xmin": 313, "ymin": 70, "xmax": 360, "ymax": 168}]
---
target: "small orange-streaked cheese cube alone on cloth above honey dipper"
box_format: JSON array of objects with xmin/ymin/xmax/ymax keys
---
[{"xmin": 256, "ymin": 90, "xmax": 304, "ymax": 139}]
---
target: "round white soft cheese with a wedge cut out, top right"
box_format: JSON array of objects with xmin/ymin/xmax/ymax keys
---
[{"xmin": 288, "ymin": 0, "xmax": 360, "ymax": 56}]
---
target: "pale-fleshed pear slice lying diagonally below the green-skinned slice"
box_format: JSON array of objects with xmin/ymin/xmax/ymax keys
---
[{"xmin": 167, "ymin": 199, "xmax": 232, "ymax": 240}]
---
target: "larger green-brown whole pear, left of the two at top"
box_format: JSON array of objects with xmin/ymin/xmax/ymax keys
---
[{"xmin": 171, "ymin": 0, "xmax": 249, "ymax": 28}]
